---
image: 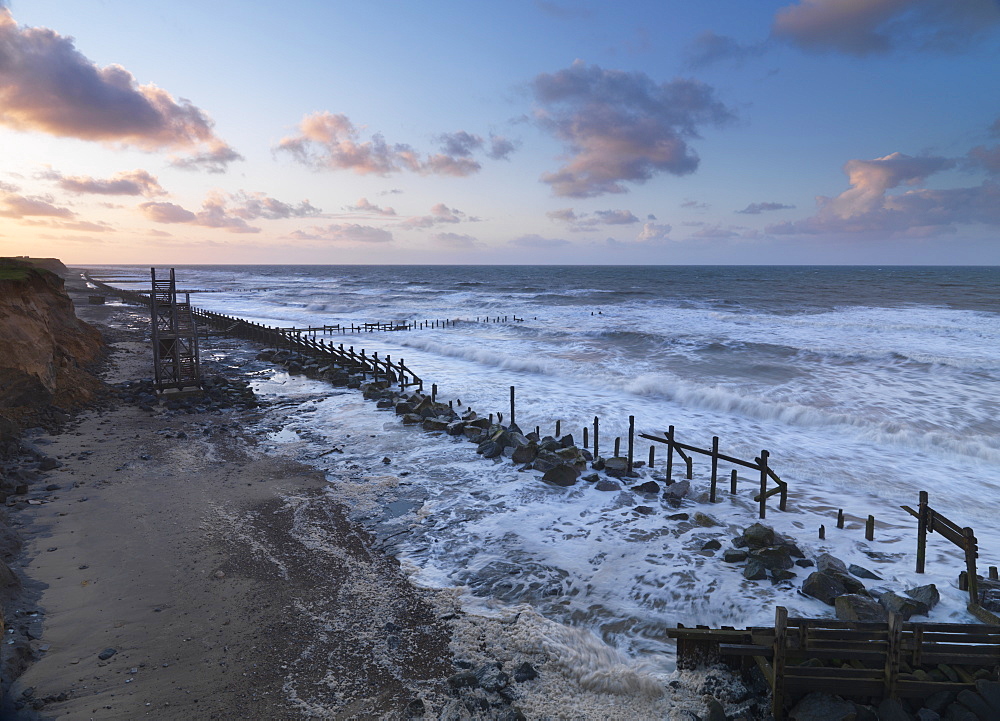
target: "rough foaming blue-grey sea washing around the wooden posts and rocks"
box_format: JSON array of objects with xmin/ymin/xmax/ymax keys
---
[{"xmin": 92, "ymin": 265, "xmax": 1000, "ymax": 670}]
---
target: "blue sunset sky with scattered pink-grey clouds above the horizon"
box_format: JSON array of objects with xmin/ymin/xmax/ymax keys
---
[{"xmin": 0, "ymin": 0, "xmax": 1000, "ymax": 265}]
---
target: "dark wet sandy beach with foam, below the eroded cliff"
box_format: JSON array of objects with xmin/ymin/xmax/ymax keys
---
[{"xmin": 4, "ymin": 278, "xmax": 744, "ymax": 719}]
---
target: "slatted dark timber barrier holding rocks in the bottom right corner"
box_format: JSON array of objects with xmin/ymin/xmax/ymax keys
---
[{"xmin": 667, "ymin": 606, "xmax": 1000, "ymax": 721}]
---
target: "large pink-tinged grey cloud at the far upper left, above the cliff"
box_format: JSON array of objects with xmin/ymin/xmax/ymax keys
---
[{"xmin": 0, "ymin": 7, "xmax": 238, "ymax": 169}]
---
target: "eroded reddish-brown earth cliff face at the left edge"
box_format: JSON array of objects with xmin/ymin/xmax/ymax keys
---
[{"xmin": 0, "ymin": 258, "xmax": 104, "ymax": 420}]
